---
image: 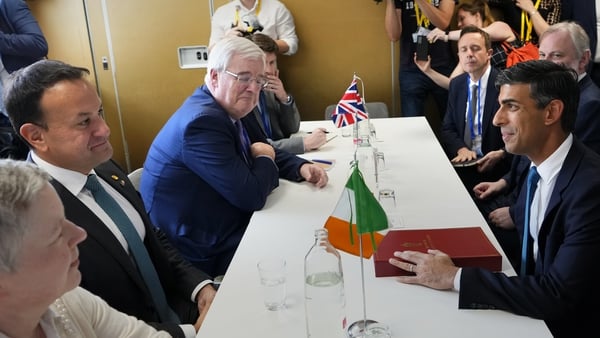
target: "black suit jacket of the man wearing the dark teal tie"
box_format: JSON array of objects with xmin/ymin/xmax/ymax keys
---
[{"xmin": 51, "ymin": 161, "xmax": 209, "ymax": 337}]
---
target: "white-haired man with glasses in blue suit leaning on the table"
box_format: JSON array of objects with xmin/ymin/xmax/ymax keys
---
[{"xmin": 140, "ymin": 37, "xmax": 328, "ymax": 275}]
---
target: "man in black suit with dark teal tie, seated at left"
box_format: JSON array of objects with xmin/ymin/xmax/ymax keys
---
[{"xmin": 6, "ymin": 60, "xmax": 215, "ymax": 337}]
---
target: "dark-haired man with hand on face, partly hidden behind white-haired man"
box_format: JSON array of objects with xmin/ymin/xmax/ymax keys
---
[{"xmin": 247, "ymin": 33, "xmax": 327, "ymax": 154}]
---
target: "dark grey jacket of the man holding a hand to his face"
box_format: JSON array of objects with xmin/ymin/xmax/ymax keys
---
[{"xmin": 252, "ymin": 91, "xmax": 304, "ymax": 154}]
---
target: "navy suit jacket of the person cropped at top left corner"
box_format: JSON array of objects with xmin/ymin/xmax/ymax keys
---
[{"xmin": 0, "ymin": 0, "xmax": 48, "ymax": 73}]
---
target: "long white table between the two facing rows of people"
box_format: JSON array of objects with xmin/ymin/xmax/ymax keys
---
[{"xmin": 197, "ymin": 117, "xmax": 551, "ymax": 338}]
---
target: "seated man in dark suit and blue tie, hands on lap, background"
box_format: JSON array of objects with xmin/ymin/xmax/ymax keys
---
[{"xmin": 441, "ymin": 26, "xmax": 510, "ymax": 191}]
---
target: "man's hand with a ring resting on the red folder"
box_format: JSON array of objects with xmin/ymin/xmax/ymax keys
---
[{"xmin": 389, "ymin": 250, "xmax": 458, "ymax": 290}]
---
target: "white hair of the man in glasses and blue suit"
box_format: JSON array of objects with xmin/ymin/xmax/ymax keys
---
[{"xmin": 205, "ymin": 36, "xmax": 266, "ymax": 84}]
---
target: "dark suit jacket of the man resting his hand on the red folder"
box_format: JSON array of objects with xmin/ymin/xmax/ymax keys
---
[{"xmin": 459, "ymin": 139, "xmax": 600, "ymax": 337}]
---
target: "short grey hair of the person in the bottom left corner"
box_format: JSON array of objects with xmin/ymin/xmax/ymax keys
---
[{"xmin": 0, "ymin": 159, "xmax": 50, "ymax": 273}]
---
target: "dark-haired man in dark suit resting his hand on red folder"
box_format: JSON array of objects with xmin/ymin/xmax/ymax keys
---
[{"xmin": 390, "ymin": 60, "xmax": 600, "ymax": 337}]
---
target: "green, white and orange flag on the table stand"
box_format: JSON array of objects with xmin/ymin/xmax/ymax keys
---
[{"xmin": 325, "ymin": 165, "xmax": 388, "ymax": 258}]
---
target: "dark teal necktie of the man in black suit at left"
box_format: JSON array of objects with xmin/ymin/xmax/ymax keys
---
[{"xmin": 85, "ymin": 175, "xmax": 179, "ymax": 324}]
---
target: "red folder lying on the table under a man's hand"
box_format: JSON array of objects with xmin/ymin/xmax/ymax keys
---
[{"xmin": 374, "ymin": 227, "xmax": 502, "ymax": 277}]
